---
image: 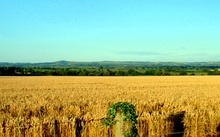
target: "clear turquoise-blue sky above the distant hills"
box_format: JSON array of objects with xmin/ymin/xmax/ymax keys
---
[{"xmin": 0, "ymin": 0, "xmax": 220, "ymax": 62}]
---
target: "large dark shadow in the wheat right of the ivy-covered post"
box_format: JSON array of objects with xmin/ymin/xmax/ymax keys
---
[{"xmin": 167, "ymin": 111, "xmax": 185, "ymax": 137}]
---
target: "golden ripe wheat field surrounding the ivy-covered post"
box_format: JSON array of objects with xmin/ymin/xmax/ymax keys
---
[{"xmin": 0, "ymin": 76, "xmax": 220, "ymax": 137}]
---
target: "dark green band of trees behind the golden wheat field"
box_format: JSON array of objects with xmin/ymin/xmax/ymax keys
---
[{"xmin": 0, "ymin": 67, "xmax": 220, "ymax": 76}]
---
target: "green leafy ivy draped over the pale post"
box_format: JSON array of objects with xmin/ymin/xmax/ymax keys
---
[{"xmin": 102, "ymin": 102, "xmax": 138, "ymax": 137}]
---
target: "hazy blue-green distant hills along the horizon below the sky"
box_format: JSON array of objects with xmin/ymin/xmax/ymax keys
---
[{"xmin": 0, "ymin": 60, "xmax": 220, "ymax": 68}]
